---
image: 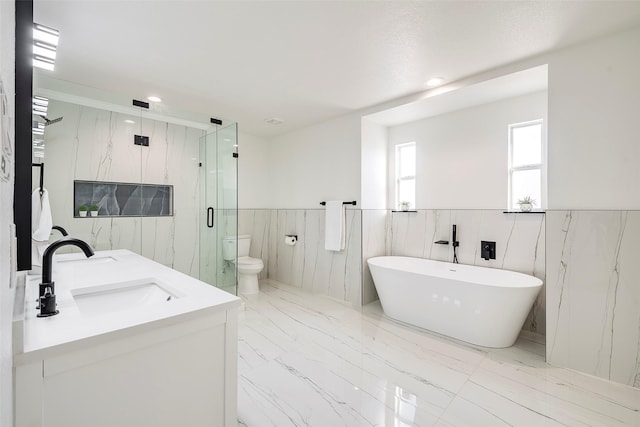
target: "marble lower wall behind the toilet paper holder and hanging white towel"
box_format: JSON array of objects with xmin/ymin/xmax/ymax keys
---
[{"xmin": 238, "ymin": 209, "xmax": 362, "ymax": 306}]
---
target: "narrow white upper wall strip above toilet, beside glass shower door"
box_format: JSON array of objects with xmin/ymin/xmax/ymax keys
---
[{"xmin": 238, "ymin": 132, "xmax": 271, "ymax": 209}]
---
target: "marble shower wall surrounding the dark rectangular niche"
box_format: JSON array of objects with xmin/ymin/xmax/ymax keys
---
[{"xmin": 44, "ymin": 100, "xmax": 203, "ymax": 277}]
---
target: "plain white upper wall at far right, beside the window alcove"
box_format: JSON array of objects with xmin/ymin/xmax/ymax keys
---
[{"xmin": 548, "ymin": 28, "xmax": 640, "ymax": 209}]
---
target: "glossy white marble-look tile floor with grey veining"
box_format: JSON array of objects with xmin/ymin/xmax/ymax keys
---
[{"xmin": 238, "ymin": 283, "xmax": 640, "ymax": 427}]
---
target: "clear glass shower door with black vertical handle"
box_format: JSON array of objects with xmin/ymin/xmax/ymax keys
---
[{"xmin": 199, "ymin": 123, "xmax": 238, "ymax": 295}]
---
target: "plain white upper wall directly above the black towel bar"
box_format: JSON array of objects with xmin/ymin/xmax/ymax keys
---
[{"xmin": 268, "ymin": 114, "xmax": 361, "ymax": 209}]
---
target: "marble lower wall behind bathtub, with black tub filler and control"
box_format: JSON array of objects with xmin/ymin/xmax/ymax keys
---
[{"xmin": 377, "ymin": 210, "xmax": 546, "ymax": 334}]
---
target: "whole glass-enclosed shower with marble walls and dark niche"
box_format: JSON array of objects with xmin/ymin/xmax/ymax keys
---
[{"xmin": 32, "ymin": 71, "xmax": 238, "ymax": 293}]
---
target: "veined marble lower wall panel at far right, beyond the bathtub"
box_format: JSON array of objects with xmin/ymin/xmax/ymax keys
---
[{"xmin": 546, "ymin": 211, "xmax": 640, "ymax": 388}]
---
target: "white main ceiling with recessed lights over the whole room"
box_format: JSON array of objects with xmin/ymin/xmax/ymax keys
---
[{"xmin": 34, "ymin": 0, "xmax": 640, "ymax": 137}]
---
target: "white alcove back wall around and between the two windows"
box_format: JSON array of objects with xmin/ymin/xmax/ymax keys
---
[{"xmin": 389, "ymin": 92, "xmax": 547, "ymax": 209}]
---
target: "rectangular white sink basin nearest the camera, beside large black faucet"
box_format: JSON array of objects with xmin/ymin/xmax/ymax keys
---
[{"xmin": 71, "ymin": 278, "xmax": 179, "ymax": 316}]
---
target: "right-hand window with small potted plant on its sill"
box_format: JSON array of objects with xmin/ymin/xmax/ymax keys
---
[{"xmin": 509, "ymin": 120, "xmax": 546, "ymax": 210}]
